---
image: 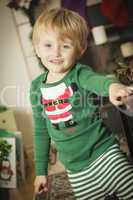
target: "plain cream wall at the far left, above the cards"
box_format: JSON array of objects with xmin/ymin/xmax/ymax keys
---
[{"xmin": 0, "ymin": 0, "xmax": 32, "ymax": 153}]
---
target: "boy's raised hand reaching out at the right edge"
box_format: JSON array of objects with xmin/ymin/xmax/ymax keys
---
[{"xmin": 109, "ymin": 83, "xmax": 133, "ymax": 106}]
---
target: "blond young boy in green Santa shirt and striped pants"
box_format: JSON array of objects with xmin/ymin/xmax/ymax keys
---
[{"xmin": 30, "ymin": 9, "xmax": 133, "ymax": 200}]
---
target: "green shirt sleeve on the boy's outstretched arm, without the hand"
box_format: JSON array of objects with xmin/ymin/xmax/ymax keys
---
[{"xmin": 77, "ymin": 65, "xmax": 119, "ymax": 96}]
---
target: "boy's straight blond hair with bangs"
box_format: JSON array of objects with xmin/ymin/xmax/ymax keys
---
[{"xmin": 33, "ymin": 8, "xmax": 89, "ymax": 55}]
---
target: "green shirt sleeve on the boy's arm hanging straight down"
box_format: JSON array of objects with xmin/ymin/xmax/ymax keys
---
[{"xmin": 30, "ymin": 79, "xmax": 50, "ymax": 176}]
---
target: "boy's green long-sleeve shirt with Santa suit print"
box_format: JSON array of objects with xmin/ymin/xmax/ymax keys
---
[{"xmin": 30, "ymin": 63, "xmax": 117, "ymax": 175}]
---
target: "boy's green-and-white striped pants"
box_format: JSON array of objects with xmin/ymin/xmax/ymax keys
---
[{"xmin": 68, "ymin": 145, "xmax": 133, "ymax": 200}]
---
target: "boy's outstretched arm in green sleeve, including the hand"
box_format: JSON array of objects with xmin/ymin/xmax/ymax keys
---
[{"xmin": 77, "ymin": 66, "xmax": 133, "ymax": 106}]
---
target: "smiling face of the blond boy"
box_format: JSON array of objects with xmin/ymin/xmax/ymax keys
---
[{"xmin": 36, "ymin": 30, "xmax": 76, "ymax": 73}]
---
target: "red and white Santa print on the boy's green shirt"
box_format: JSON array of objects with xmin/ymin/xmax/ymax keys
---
[{"xmin": 41, "ymin": 83, "xmax": 76, "ymax": 128}]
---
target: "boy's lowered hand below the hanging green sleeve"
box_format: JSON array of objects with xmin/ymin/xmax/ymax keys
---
[{"xmin": 34, "ymin": 176, "xmax": 48, "ymax": 194}]
